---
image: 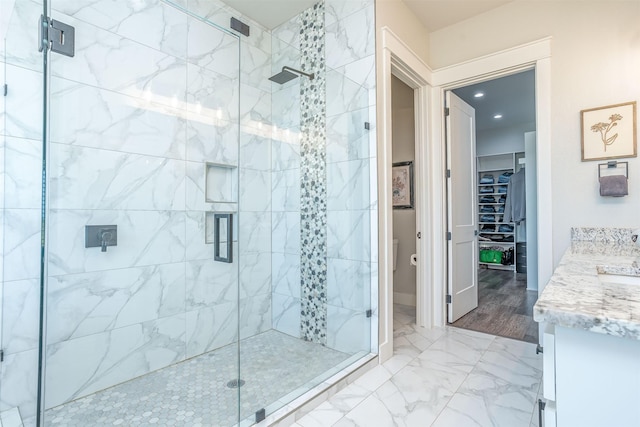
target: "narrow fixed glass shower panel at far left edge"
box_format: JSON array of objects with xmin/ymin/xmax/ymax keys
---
[{"xmin": 0, "ymin": 0, "xmax": 43, "ymax": 426}]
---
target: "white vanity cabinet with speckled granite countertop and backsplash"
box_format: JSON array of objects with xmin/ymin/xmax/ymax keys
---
[{"xmin": 533, "ymin": 231, "xmax": 640, "ymax": 427}]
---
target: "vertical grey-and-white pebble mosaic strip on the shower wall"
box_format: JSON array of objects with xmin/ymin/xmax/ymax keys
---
[{"xmin": 300, "ymin": 1, "xmax": 327, "ymax": 344}]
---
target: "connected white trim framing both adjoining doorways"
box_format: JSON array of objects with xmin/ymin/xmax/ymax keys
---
[{"xmin": 376, "ymin": 31, "xmax": 553, "ymax": 363}]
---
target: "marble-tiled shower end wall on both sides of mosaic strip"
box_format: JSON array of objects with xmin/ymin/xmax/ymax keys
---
[{"xmin": 272, "ymin": 0, "xmax": 377, "ymax": 353}]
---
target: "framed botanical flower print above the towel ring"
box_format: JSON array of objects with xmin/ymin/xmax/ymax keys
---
[{"xmin": 580, "ymin": 101, "xmax": 638, "ymax": 162}]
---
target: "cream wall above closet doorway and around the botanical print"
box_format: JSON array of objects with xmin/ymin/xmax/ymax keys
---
[{"xmin": 429, "ymin": 1, "xmax": 640, "ymax": 263}]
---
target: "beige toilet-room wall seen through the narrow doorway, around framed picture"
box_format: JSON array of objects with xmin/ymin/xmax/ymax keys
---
[{"xmin": 391, "ymin": 77, "xmax": 420, "ymax": 305}]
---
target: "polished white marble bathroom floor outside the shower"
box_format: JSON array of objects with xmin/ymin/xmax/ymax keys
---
[{"xmin": 299, "ymin": 305, "xmax": 542, "ymax": 427}]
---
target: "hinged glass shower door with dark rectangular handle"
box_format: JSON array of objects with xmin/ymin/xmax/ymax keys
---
[{"xmin": 43, "ymin": 0, "xmax": 240, "ymax": 425}]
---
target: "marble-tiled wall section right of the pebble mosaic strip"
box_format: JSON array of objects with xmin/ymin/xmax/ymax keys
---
[{"xmin": 325, "ymin": 0, "xmax": 378, "ymax": 353}]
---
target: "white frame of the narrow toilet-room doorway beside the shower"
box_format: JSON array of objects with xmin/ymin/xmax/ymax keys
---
[{"xmin": 376, "ymin": 27, "xmax": 440, "ymax": 363}]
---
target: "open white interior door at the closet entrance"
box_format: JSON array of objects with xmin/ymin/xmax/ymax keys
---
[{"xmin": 446, "ymin": 91, "xmax": 478, "ymax": 322}]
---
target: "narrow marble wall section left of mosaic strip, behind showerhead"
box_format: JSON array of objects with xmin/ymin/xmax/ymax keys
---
[{"xmin": 271, "ymin": 16, "xmax": 301, "ymax": 338}]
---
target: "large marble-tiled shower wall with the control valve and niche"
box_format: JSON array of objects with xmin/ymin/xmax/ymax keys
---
[{"xmin": 0, "ymin": 0, "xmax": 271, "ymax": 418}]
